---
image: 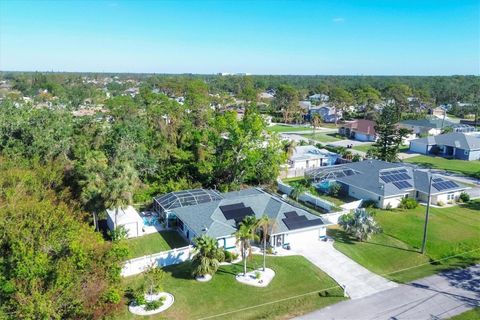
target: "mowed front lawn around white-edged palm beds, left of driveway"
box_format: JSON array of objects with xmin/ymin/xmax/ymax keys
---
[{"xmin": 119, "ymin": 256, "xmax": 345, "ymax": 319}]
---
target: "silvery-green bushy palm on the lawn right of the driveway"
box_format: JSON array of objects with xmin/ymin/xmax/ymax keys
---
[{"xmin": 338, "ymin": 208, "xmax": 382, "ymax": 241}]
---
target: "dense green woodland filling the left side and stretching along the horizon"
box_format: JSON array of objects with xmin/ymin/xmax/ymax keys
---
[{"xmin": 0, "ymin": 73, "xmax": 480, "ymax": 319}]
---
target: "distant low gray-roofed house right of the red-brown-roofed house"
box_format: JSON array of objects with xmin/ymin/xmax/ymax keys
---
[{"xmin": 398, "ymin": 117, "xmax": 475, "ymax": 137}]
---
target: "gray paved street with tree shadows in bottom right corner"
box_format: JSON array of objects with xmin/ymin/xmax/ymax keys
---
[{"xmin": 296, "ymin": 265, "xmax": 480, "ymax": 320}]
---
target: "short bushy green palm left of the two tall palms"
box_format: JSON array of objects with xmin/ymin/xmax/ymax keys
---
[{"xmin": 192, "ymin": 234, "xmax": 224, "ymax": 277}]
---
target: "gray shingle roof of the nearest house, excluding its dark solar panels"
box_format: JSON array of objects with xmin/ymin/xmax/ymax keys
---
[{"xmin": 171, "ymin": 188, "xmax": 326, "ymax": 238}]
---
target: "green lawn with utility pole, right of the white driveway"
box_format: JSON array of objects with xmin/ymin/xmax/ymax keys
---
[{"xmin": 329, "ymin": 200, "xmax": 480, "ymax": 282}]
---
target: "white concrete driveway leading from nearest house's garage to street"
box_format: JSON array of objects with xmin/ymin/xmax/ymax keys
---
[{"xmin": 292, "ymin": 241, "xmax": 397, "ymax": 299}]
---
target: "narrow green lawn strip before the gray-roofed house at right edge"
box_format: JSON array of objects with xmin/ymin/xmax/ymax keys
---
[{"xmin": 403, "ymin": 155, "xmax": 480, "ymax": 176}]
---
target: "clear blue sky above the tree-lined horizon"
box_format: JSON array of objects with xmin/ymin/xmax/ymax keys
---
[{"xmin": 0, "ymin": 0, "xmax": 480, "ymax": 75}]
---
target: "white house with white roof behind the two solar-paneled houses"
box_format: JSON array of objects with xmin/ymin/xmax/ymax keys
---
[{"xmin": 288, "ymin": 145, "xmax": 338, "ymax": 170}]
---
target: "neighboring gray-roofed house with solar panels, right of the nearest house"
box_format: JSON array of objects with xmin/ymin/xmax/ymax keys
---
[{"xmin": 306, "ymin": 160, "xmax": 467, "ymax": 209}]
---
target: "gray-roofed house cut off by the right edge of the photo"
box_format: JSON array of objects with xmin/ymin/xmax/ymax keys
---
[{"xmin": 410, "ymin": 132, "xmax": 480, "ymax": 160}]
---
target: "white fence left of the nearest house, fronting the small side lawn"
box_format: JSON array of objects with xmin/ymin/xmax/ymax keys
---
[{"xmin": 121, "ymin": 246, "xmax": 193, "ymax": 277}]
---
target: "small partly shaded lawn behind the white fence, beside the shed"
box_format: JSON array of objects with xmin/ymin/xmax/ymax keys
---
[{"xmin": 126, "ymin": 231, "xmax": 188, "ymax": 258}]
